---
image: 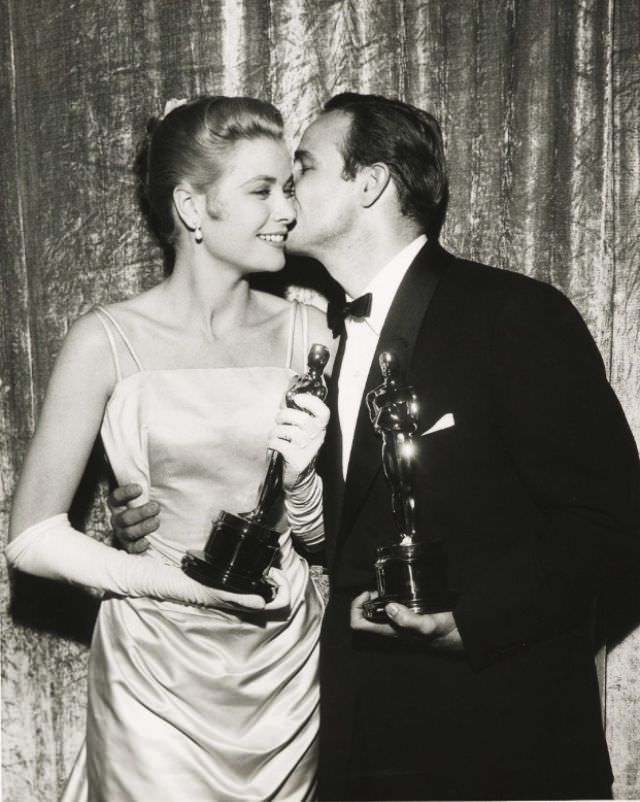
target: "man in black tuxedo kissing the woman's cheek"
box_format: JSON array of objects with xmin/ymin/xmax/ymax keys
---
[{"xmin": 112, "ymin": 94, "xmax": 640, "ymax": 799}]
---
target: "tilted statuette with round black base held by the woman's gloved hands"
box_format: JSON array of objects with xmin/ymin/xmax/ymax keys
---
[{"xmin": 182, "ymin": 343, "xmax": 329, "ymax": 602}]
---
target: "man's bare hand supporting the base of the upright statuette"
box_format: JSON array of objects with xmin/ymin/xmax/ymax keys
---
[{"xmin": 351, "ymin": 590, "xmax": 464, "ymax": 652}]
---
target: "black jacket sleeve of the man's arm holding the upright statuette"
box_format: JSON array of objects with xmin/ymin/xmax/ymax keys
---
[{"xmin": 454, "ymin": 284, "xmax": 640, "ymax": 669}]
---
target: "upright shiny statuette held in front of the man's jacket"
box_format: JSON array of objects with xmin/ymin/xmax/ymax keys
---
[{"xmin": 364, "ymin": 351, "xmax": 457, "ymax": 623}]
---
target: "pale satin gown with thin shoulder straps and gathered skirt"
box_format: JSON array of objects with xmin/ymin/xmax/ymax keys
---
[{"xmin": 63, "ymin": 305, "xmax": 323, "ymax": 802}]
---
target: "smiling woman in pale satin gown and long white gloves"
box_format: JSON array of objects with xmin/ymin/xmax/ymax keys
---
[{"xmin": 7, "ymin": 97, "xmax": 328, "ymax": 802}]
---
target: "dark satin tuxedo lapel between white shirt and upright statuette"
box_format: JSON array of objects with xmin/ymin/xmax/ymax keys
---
[{"xmin": 334, "ymin": 243, "xmax": 452, "ymax": 537}]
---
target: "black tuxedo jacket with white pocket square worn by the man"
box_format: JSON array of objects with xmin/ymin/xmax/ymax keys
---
[{"xmin": 319, "ymin": 244, "xmax": 640, "ymax": 799}]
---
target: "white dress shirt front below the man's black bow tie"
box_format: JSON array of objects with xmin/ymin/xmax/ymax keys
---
[{"xmin": 338, "ymin": 234, "xmax": 427, "ymax": 478}]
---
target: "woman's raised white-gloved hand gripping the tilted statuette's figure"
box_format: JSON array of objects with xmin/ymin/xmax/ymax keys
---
[{"xmin": 267, "ymin": 393, "xmax": 329, "ymax": 489}]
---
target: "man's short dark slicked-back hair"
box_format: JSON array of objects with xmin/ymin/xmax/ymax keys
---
[{"xmin": 324, "ymin": 92, "xmax": 449, "ymax": 240}]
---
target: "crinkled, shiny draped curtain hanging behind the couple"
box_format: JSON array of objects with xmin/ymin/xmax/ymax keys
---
[{"xmin": 0, "ymin": 0, "xmax": 640, "ymax": 802}]
